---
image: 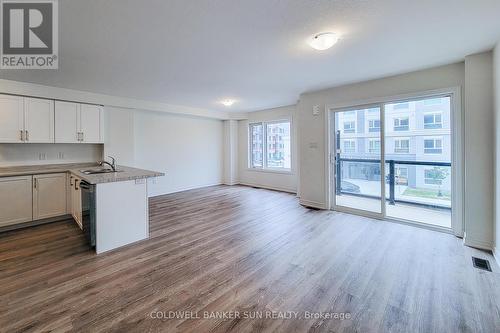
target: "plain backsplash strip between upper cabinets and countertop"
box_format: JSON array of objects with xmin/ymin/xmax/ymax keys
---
[{"xmin": 0, "ymin": 143, "xmax": 104, "ymax": 167}]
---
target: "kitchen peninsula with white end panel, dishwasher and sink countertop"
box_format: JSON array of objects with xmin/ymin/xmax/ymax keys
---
[{"xmin": 69, "ymin": 166, "xmax": 163, "ymax": 254}]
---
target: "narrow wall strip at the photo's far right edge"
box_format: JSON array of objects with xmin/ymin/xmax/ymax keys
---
[{"xmin": 493, "ymin": 42, "xmax": 500, "ymax": 265}]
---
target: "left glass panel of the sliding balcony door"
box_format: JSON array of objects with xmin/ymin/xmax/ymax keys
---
[{"xmin": 332, "ymin": 107, "xmax": 382, "ymax": 214}]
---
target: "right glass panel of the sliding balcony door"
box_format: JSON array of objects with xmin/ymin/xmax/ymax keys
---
[{"xmin": 384, "ymin": 96, "xmax": 452, "ymax": 228}]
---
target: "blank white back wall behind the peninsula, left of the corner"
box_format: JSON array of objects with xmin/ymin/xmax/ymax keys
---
[{"xmin": 134, "ymin": 111, "xmax": 224, "ymax": 196}]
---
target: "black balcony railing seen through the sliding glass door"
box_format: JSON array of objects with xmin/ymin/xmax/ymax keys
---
[{"xmin": 335, "ymin": 154, "xmax": 451, "ymax": 209}]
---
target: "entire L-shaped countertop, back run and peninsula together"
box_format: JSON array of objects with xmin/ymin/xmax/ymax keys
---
[{"xmin": 0, "ymin": 163, "xmax": 165, "ymax": 184}]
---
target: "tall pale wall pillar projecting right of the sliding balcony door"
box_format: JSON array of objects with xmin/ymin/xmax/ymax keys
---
[{"xmin": 464, "ymin": 52, "xmax": 495, "ymax": 249}]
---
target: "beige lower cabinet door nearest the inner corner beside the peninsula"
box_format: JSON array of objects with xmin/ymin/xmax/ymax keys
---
[{"xmin": 33, "ymin": 173, "xmax": 66, "ymax": 220}]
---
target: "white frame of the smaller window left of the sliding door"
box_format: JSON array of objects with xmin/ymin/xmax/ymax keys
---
[{"xmin": 247, "ymin": 118, "xmax": 294, "ymax": 174}]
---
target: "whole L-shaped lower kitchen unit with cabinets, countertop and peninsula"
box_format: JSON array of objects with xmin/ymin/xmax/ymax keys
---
[{"xmin": 0, "ymin": 163, "xmax": 164, "ymax": 254}]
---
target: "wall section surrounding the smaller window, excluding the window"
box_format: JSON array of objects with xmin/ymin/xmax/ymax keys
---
[{"xmin": 238, "ymin": 105, "xmax": 298, "ymax": 193}]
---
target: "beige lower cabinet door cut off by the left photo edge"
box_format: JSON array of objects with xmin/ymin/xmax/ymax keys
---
[{"xmin": 0, "ymin": 176, "xmax": 33, "ymax": 227}]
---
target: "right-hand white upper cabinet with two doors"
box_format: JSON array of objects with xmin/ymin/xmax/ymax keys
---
[{"xmin": 55, "ymin": 101, "xmax": 104, "ymax": 143}]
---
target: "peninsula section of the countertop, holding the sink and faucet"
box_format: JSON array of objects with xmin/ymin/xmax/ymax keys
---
[{"xmin": 69, "ymin": 165, "xmax": 165, "ymax": 184}]
